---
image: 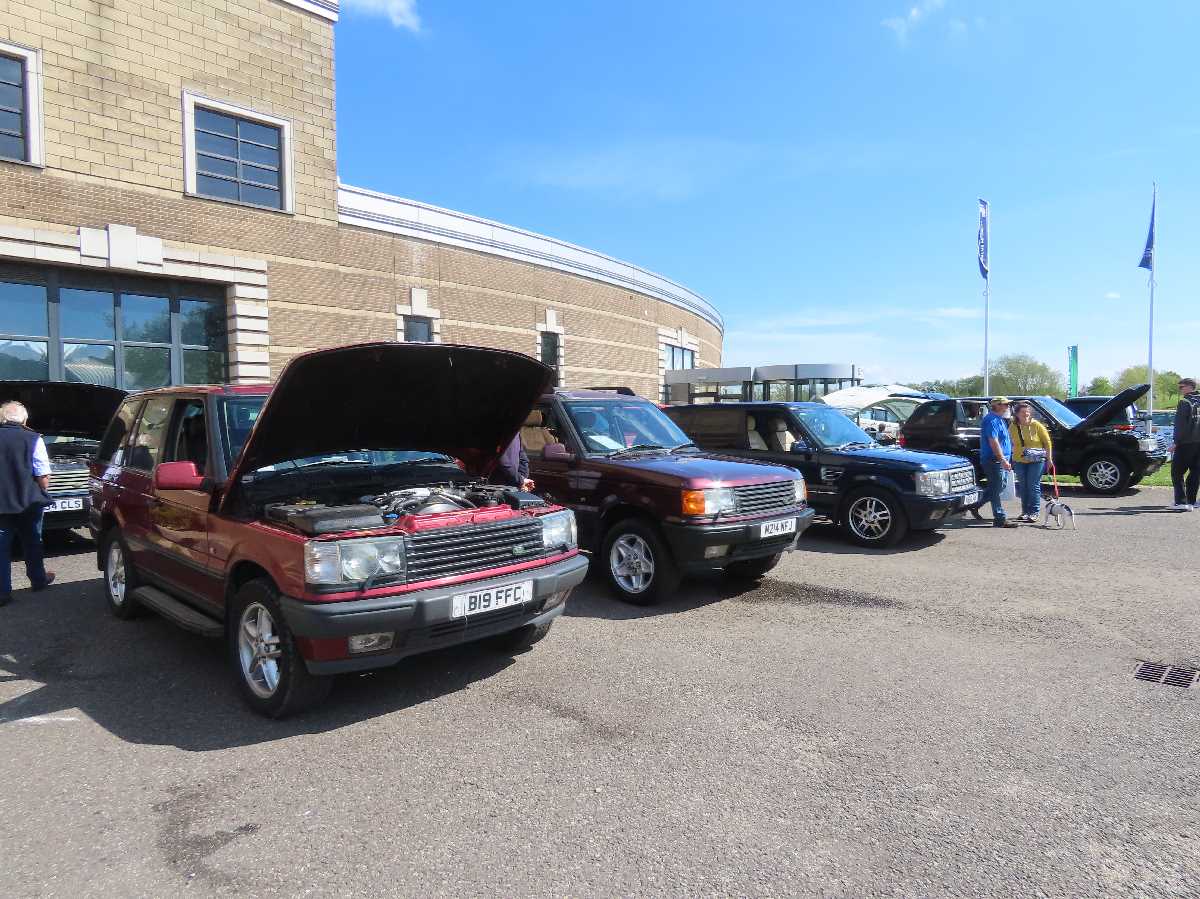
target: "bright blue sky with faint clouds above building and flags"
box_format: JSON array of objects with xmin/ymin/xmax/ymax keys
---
[{"xmin": 336, "ymin": 0, "xmax": 1200, "ymax": 380}]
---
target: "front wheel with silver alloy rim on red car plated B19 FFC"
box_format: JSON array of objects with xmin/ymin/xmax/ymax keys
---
[{"xmin": 226, "ymin": 580, "xmax": 334, "ymax": 718}]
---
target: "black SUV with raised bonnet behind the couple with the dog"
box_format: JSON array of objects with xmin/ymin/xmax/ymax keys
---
[{"xmin": 900, "ymin": 384, "xmax": 1168, "ymax": 495}]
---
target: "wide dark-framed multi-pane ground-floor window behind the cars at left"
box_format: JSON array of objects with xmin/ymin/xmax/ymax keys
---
[{"xmin": 0, "ymin": 266, "xmax": 227, "ymax": 390}]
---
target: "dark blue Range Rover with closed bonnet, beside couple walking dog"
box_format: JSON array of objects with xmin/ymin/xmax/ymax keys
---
[{"xmin": 667, "ymin": 402, "xmax": 979, "ymax": 546}]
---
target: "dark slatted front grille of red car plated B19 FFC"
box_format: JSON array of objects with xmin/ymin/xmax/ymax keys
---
[{"xmin": 404, "ymin": 519, "xmax": 546, "ymax": 583}]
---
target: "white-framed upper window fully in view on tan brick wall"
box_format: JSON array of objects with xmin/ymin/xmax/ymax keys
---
[{"xmin": 184, "ymin": 92, "xmax": 293, "ymax": 212}]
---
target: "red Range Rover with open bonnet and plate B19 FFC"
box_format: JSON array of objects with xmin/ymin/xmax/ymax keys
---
[{"xmin": 90, "ymin": 343, "xmax": 587, "ymax": 717}]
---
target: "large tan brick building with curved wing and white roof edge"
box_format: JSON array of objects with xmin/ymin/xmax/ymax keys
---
[{"xmin": 0, "ymin": 0, "xmax": 722, "ymax": 396}]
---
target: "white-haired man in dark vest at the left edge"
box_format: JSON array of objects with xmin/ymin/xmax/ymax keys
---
[{"xmin": 0, "ymin": 402, "xmax": 54, "ymax": 606}]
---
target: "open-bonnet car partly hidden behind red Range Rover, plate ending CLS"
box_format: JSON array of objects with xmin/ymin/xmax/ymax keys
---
[{"xmin": 0, "ymin": 380, "xmax": 125, "ymax": 531}]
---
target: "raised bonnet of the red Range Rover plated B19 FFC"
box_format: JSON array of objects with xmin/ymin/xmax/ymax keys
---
[{"xmin": 225, "ymin": 343, "xmax": 553, "ymax": 481}]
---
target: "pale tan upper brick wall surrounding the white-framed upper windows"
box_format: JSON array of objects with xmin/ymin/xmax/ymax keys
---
[{"xmin": 0, "ymin": 0, "xmax": 337, "ymax": 222}]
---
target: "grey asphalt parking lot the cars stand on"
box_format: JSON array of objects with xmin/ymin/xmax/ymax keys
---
[{"xmin": 0, "ymin": 490, "xmax": 1200, "ymax": 897}]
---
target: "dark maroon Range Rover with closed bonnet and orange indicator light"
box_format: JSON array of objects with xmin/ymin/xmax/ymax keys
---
[{"xmin": 521, "ymin": 390, "xmax": 812, "ymax": 605}]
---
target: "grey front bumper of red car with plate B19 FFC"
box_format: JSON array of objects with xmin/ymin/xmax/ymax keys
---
[{"xmin": 280, "ymin": 555, "xmax": 588, "ymax": 675}]
